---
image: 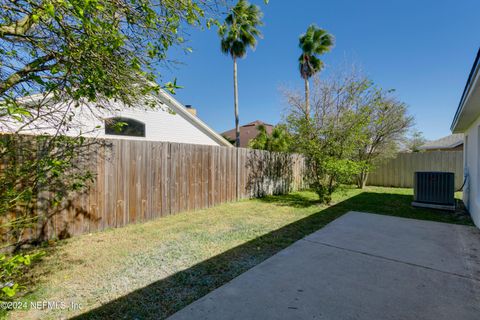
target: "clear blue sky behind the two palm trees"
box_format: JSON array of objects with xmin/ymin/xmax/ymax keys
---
[{"xmin": 159, "ymin": 0, "xmax": 480, "ymax": 139}]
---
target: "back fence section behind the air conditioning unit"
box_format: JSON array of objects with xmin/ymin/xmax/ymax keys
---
[{"xmin": 367, "ymin": 151, "xmax": 463, "ymax": 190}]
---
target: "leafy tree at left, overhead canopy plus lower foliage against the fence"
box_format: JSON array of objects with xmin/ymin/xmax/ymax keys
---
[{"xmin": 0, "ymin": 0, "xmax": 227, "ymax": 248}]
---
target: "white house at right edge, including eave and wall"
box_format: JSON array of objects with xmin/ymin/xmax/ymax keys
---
[{"xmin": 451, "ymin": 50, "xmax": 480, "ymax": 228}]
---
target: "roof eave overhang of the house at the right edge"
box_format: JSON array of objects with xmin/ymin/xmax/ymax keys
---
[{"xmin": 450, "ymin": 49, "xmax": 480, "ymax": 133}]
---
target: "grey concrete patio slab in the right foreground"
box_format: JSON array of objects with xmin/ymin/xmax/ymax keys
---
[{"xmin": 170, "ymin": 212, "xmax": 480, "ymax": 320}]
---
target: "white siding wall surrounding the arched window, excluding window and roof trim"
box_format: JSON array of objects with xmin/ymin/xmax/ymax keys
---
[{"xmin": 0, "ymin": 97, "xmax": 220, "ymax": 146}]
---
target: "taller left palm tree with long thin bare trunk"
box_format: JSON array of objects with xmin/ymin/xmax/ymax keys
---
[{"xmin": 219, "ymin": 0, "xmax": 263, "ymax": 147}]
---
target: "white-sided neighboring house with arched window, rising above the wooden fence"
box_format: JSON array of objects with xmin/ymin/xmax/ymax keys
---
[{"xmin": 0, "ymin": 90, "xmax": 232, "ymax": 147}]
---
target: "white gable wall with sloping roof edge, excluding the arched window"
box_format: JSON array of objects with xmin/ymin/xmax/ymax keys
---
[{"xmin": 0, "ymin": 90, "xmax": 232, "ymax": 147}]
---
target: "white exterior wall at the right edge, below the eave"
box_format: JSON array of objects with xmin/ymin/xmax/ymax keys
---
[{"xmin": 463, "ymin": 118, "xmax": 480, "ymax": 227}]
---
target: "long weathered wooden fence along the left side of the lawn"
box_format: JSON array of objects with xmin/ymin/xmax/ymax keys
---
[{"xmin": 15, "ymin": 140, "xmax": 304, "ymax": 238}]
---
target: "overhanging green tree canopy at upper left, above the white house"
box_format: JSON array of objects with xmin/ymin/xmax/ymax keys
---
[{"xmin": 0, "ymin": 0, "xmax": 218, "ymax": 106}]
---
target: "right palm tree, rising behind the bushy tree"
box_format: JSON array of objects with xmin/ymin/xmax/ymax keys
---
[{"xmin": 298, "ymin": 24, "xmax": 333, "ymax": 118}]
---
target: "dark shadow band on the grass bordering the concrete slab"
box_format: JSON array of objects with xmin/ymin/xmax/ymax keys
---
[{"xmin": 73, "ymin": 192, "xmax": 471, "ymax": 319}]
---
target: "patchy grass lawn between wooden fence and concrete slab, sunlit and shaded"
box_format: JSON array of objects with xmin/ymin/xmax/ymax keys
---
[{"xmin": 8, "ymin": 187, "xmax": 471, "ymax": 319}]
